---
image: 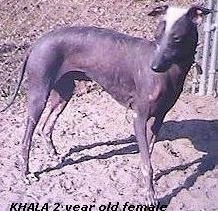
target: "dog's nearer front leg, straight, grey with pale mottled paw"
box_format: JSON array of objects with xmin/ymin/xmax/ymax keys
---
[{"xmin": 134, "ymin": 112, "xmax": 155, "ymax": 205}]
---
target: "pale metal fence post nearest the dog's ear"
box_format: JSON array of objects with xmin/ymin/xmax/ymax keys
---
[{"xmin": 199, "ymin": 0, "xmax": 213, "ymax": 95}]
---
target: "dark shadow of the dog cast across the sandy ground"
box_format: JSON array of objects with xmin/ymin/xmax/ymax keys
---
[{"xmin": 35, "ymin": 119, "xmax": 218, "ymax": 204}]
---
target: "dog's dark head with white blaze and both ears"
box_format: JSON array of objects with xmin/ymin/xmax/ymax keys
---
[{"xmin": 148, "ymin": 5, "xmax": 211, "ymax": 72}]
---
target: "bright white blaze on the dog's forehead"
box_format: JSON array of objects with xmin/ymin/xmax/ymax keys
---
[{"xmin": 164, "ymin": 7, "xmax": 188, "ymax": 33}]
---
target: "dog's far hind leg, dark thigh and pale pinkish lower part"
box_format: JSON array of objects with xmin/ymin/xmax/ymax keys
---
[{"xmin": 42, "ymin": 74, "xmax": 75, "ymax": 155}]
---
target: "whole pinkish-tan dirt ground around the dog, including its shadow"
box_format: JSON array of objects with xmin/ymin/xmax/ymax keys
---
[{"xmin": 0, "ymin": 0, "xmax": 218, "ymax": 211}]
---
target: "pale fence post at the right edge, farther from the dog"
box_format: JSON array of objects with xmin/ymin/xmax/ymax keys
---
[{"xmin": 207, "ymin": 0, "xmax": 218, "ymax": 95}]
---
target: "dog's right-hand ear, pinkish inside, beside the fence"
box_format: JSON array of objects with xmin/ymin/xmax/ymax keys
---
[{"xmin": 187, "ymin": 6, "xmax": 212, "ymax": 24}]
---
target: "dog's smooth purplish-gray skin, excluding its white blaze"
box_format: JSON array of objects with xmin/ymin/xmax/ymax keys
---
[{"xmin": 0, "ymin": 6, "xmax": 209, "ymax": 204}]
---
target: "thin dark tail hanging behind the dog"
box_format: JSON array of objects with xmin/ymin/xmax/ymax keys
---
[{"xmin": 0, "ymin": 52, "xmax": 29, "ymax": 112}]
